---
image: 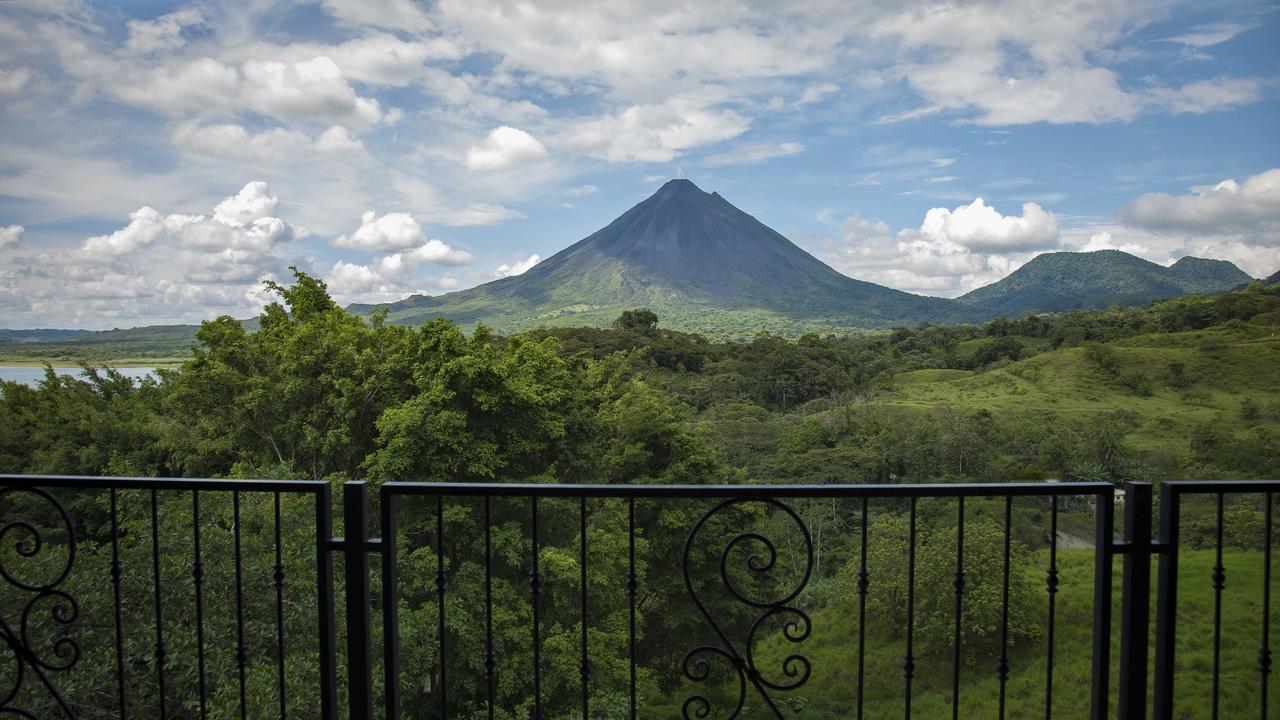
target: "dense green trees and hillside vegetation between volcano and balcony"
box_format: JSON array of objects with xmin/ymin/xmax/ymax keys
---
[{"xmin": 0, "ymin": 273, "xmax": 1280, "ymax": 717}]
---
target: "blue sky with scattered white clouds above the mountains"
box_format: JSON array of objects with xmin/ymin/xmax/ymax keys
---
[{"xmin": 0, "ymin": 0, "xmax": 1280, "ymax": 329}]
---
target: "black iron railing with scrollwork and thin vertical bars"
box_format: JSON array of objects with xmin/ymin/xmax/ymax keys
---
[{"xmin": 0, "ymin": 475, "xmax": 1280, "ymax": 720}]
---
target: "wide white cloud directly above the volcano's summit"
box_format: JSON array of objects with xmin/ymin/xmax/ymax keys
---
[{"xmin": 558, "ymin": 96, "xmax": 750, "ymax": 163}]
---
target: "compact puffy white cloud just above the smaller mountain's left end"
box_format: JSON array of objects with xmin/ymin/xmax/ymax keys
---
[{"xmin": 920, "ymin": 197, "xmax": 1059, "ymax": 252}]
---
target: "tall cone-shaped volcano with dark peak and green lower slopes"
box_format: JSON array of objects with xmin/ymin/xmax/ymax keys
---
[{"xmin": 351, "ymin": 179, "xmax": 983, "ymax": 336}]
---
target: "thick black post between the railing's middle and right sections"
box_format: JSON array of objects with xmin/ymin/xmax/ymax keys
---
[{"xmin": 1116, "ymin": 483, "xmax": 1151, "ymax": 720}]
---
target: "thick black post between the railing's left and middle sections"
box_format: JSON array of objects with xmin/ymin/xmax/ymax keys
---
[{"xmin": 342, "ymin": 482, "xmax": 374, "ymax": 720}]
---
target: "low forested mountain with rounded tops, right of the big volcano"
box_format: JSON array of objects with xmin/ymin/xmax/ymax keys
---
[{"xmin": 960, "ymin": 250, "xmax": 1249, "ymax": 316}]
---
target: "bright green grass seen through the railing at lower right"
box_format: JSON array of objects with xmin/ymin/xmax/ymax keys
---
[{"xmin": 652, "ymin": 548, "xmax": 1280, "ymax": 719}]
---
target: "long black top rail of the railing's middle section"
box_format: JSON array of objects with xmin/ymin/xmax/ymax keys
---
[{"xmin": 381, "ymin": 482, "xmax": 1115, "ymax": 498}]
